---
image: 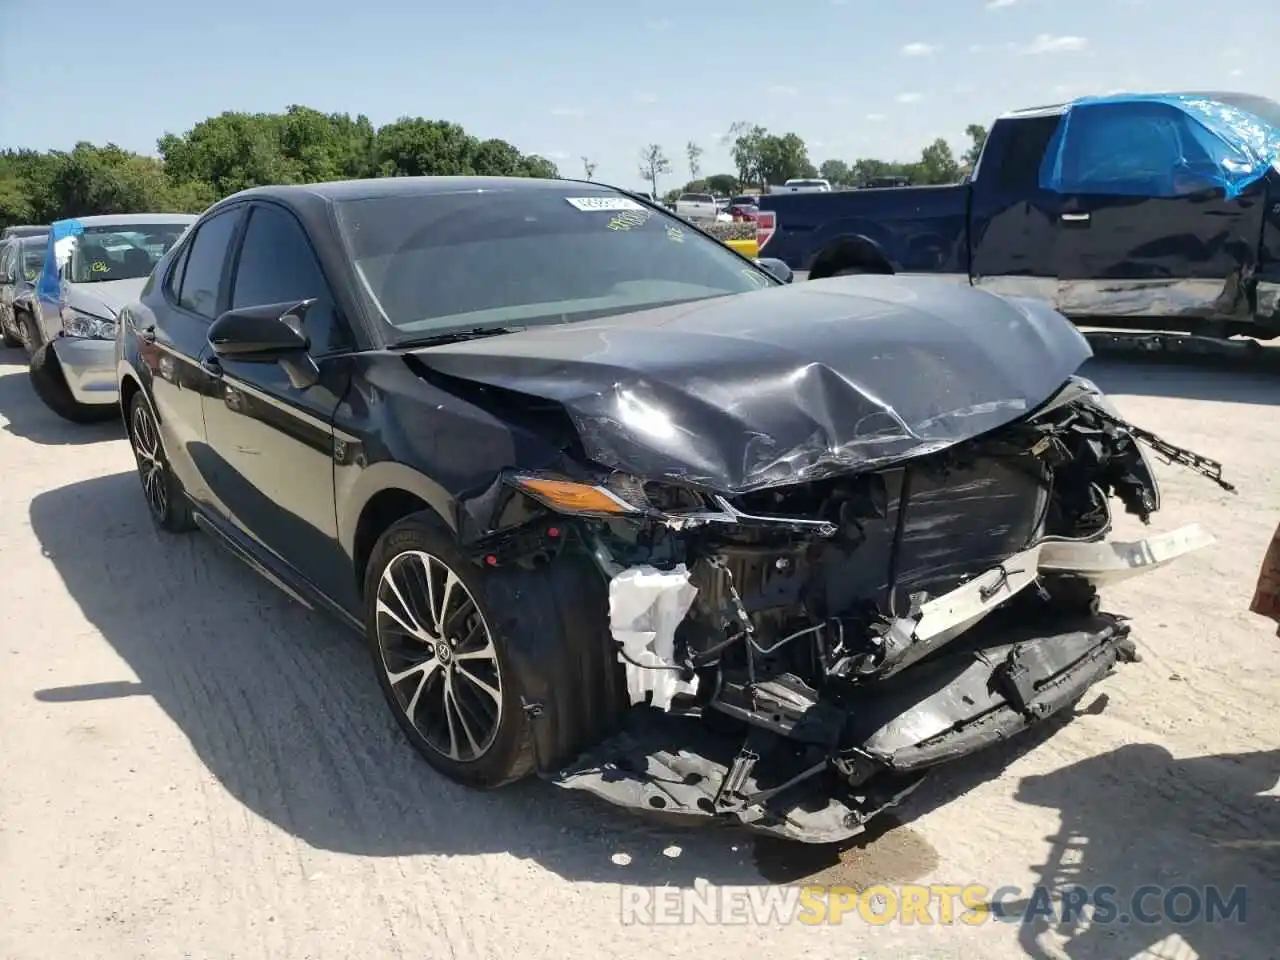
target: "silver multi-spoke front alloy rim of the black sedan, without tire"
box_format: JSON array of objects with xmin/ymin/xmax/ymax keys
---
[{"xmin": 375, "ymin": 550, "xmax": 503, "ymax": 764}]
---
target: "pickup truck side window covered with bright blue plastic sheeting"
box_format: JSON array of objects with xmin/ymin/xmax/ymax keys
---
[{"xmin": 1059, "ymin": 102, "xmax": 1185, "ymax": 197}]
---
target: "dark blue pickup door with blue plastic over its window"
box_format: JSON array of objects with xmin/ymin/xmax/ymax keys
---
[{"xmin": 1059, "ymin": 101, "xmax": 1266, "ymax": 319}]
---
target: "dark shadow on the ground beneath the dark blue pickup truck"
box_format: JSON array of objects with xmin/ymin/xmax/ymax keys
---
[{"xmin": 1080, "ymin": 358, "xmax": 1280, "ymax": 406}]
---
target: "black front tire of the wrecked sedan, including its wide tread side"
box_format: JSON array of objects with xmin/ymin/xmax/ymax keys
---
[{"xmin": 365, "ymin": 513, "xmax": 628, "ymax": 790}]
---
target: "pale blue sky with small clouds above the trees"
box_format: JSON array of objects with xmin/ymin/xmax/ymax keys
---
[{"xmin": 0, "ymin": 0, "xmax": 1280, "ymax": 188}]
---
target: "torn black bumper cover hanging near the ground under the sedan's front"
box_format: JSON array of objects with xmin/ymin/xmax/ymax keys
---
[{"xmin": 548, "ymin": 614, "xmax": 1134, "ymax": 844}]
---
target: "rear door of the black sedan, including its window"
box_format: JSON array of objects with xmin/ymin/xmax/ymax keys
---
[{"xmin": 147, "ymin": 204, "xmax": 246, "ymax": 506}]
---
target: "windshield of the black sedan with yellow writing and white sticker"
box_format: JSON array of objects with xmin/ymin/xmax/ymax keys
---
[{"xmin": 335, "ymin": 184, "xmax": 774, "ymax": 339}]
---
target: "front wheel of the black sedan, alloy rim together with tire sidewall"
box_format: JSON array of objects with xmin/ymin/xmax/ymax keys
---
[{"xmin": 365, "ymin": 517, "xmax": 532, "ymax": 788}]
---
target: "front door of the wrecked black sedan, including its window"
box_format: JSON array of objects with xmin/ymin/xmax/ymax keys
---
[{"xmin": 205, "ymin": 201, "xmax": 356, "ymax": 604}]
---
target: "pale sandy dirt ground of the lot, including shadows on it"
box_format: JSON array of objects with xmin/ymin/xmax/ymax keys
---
[{"xmin": 0, "ymin": 351, "xmax": 1280, "ymax": 960}]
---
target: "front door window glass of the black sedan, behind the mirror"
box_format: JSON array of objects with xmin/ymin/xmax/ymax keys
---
[{"xmin": 232, "ymin": 204, "xmax": 349, "ymax": 356}]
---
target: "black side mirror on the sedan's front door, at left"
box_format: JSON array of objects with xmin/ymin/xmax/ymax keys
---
[{"xmin": 209, "ymin": 298, "xmax": 320, "ymax": 390}]
